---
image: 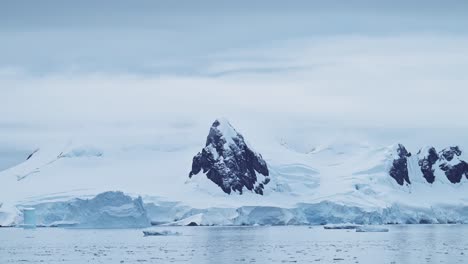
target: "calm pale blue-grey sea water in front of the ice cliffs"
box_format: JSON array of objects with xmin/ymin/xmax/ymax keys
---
[{"xmin": 0, "ymin": 225, "xmax": 468, "ymax": 264}]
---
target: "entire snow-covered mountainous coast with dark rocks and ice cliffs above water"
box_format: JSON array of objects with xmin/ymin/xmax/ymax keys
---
[{"xmin": 0, "ymin": 119, "xmax": 468, "ymax": 227}]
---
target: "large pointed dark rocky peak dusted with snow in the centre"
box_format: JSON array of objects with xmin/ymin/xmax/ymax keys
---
[{"xmin": 189, "ymin": 119, "xmax": 270, "ymax": 195}]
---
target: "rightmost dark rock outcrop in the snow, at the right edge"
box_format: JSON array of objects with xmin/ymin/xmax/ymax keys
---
[{"xmin": 439, "ymin": 146, "xmax": 468, "ymax": 183}]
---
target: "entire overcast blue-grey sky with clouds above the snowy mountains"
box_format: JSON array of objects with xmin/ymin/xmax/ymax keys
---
[{"xmin": 0, "ymin": 0, "xmax": 468, "ymax": 167}]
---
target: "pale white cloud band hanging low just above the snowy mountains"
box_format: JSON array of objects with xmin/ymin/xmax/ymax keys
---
[{"xmin": 0, "ymin": 34, "xmax": 468, "ymax": 129}]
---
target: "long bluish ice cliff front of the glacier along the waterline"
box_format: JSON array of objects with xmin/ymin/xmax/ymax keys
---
[{"xmin": 10, "ymin": 195, "xmax": 468, "ymax": 228}]
